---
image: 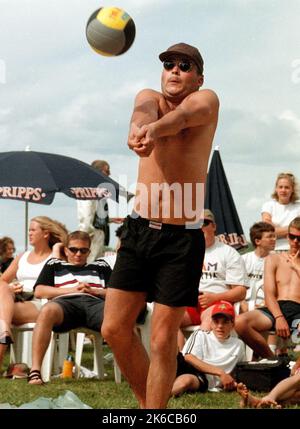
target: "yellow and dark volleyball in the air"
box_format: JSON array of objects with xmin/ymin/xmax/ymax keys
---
[{"xmin": 86, "ymin": 7, "xmax": 135, "ymax": 57}]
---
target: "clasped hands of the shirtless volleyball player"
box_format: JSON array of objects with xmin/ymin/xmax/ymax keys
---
[{"xmin": 128, "ymin": 124, "xmax": 155, "ymax": 157}]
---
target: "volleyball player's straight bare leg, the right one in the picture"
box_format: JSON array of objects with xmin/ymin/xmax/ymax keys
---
[{"xmin": 146, "ymin": 303, "xmax": 185, "ymax": 409}]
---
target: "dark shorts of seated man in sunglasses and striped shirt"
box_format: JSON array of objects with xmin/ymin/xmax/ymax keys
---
[{"xmin": 51, "ymin": 294, "xmax": 105, "ymax": 332}]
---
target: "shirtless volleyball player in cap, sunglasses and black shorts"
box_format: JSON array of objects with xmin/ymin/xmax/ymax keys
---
[{"xmin": 102, "ymin": 43, "xmax": 219, "ymax": 408}]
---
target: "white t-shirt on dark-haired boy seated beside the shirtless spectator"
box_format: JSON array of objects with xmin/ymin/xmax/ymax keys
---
[{"xmin": 242, "ymin": 251, "xmax": 265, "ymax": 305}]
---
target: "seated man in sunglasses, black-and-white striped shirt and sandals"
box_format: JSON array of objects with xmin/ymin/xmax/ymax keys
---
[{"xmin": 28, "ymin": 231, "xmax": 111, "ymax": 384}]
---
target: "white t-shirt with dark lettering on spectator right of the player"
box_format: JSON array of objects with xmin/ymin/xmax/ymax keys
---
[{"xmin": 199, "ymin": 240, "xmax": 249, "ymax": 293}]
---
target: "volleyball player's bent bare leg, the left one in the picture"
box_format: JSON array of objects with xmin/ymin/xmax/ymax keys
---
[{"xmin": 101, "ymin": 289, "xmax": 149, "ymax": 408}]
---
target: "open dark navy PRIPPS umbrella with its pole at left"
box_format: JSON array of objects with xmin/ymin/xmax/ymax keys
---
[{"xmin": 0, "ymin": 150, "xmax": 126, "ymax": 248}]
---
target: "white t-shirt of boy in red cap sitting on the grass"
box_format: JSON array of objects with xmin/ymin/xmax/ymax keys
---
[{"xmin": 182, "ymin": 329, "xmax": 246, "ymax": 392}]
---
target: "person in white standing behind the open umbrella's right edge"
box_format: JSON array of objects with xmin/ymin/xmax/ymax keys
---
[{"xmin": 77, "ymin": 159, "xmax": 123, "ymax": 262}]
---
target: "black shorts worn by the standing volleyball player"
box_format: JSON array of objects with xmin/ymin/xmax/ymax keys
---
[{"xmin": 108, "ymin": 216, "xmax": 205, "ymax": 307}]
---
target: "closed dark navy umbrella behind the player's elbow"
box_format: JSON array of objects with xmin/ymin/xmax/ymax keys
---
[{"xmin": 205, "ymin": 146, "xmax": 248, "ymax": 249}]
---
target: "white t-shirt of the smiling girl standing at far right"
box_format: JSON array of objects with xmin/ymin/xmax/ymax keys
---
[{"xmin": 261, "ymin": 200, "xmax": 300, "ymax": 250}]
